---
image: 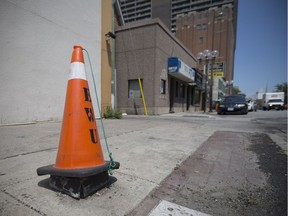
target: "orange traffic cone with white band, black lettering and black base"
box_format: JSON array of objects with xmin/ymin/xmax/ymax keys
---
[{"xmin": 37, "ymin": 46, "xmax": 120, "ymax": 198}]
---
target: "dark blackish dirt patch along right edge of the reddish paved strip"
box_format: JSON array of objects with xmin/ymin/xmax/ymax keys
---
[{"xmin": 249, "ymin": 134, "xmax": 287, "ymax": 215}]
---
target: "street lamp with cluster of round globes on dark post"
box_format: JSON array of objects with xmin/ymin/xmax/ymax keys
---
[{"xmin": 197, "ymin": 49, "xmax": 219, "ymax": 112}]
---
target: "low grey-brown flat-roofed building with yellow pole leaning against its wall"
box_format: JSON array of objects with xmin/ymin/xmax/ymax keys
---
[{"xmin": 115, "ymin": 19, "xmax": 202, "ymax": 115}]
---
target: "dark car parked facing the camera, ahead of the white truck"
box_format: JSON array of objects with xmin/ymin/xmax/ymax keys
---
[{"xmin": 217, "ymin": 95, "xmax": 248, "ymax": 114}]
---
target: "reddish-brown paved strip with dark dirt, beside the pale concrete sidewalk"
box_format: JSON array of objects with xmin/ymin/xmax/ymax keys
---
[{"xmin": 130, "ymin": 131, "xmax": 287, "ymax": 216}]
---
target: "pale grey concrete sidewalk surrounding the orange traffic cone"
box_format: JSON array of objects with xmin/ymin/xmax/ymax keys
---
[{"xmin": 0, "ymin": 113, "xmax": 287, "ymax": 216}]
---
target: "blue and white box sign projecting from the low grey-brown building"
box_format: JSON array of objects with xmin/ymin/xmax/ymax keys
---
[{"xmin": 168, "ymin": 57, "xmax": 195, "ymax": 82}]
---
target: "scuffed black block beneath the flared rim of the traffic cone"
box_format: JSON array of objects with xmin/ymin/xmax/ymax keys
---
[{"xmin": 49, "ymin": 171, "xmax": 109, "ymax": 199}]
